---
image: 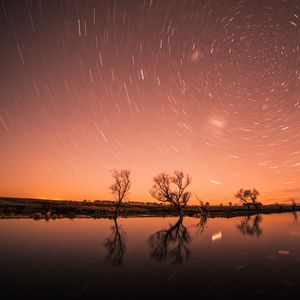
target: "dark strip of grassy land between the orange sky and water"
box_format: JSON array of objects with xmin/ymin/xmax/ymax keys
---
[{"xmin": 0, "ymin": 197, "xmax": 300, "ymax": 219}]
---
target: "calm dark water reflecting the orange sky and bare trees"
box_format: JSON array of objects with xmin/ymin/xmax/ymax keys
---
[{"xmin": 0, "ymin": 214, "xmax": 300, "ymax": 299}]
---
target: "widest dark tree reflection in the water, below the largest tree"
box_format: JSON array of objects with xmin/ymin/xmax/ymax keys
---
[{"xmin": 148, "ymin": 216, "xmax": 191, "ymax": 264}]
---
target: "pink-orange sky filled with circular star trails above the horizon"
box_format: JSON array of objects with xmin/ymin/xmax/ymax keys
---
[{"xmin": 0, "ymin": 0, "xmax": 300, "ymax": 204}]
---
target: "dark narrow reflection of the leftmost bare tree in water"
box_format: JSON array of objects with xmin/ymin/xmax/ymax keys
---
[{"xmin": 104, "ymin": 217, "xmax": 126, "ymax": 266}]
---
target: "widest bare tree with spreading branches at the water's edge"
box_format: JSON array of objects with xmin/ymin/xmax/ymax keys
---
[{"xmin": 150, "ymin": 171, "xmax": 191, "ymax": 215}]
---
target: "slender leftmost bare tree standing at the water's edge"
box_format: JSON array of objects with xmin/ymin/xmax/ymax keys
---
[{"xmin": 109, "ymin": 169, "xmax": 131, "ymax": 216}]
